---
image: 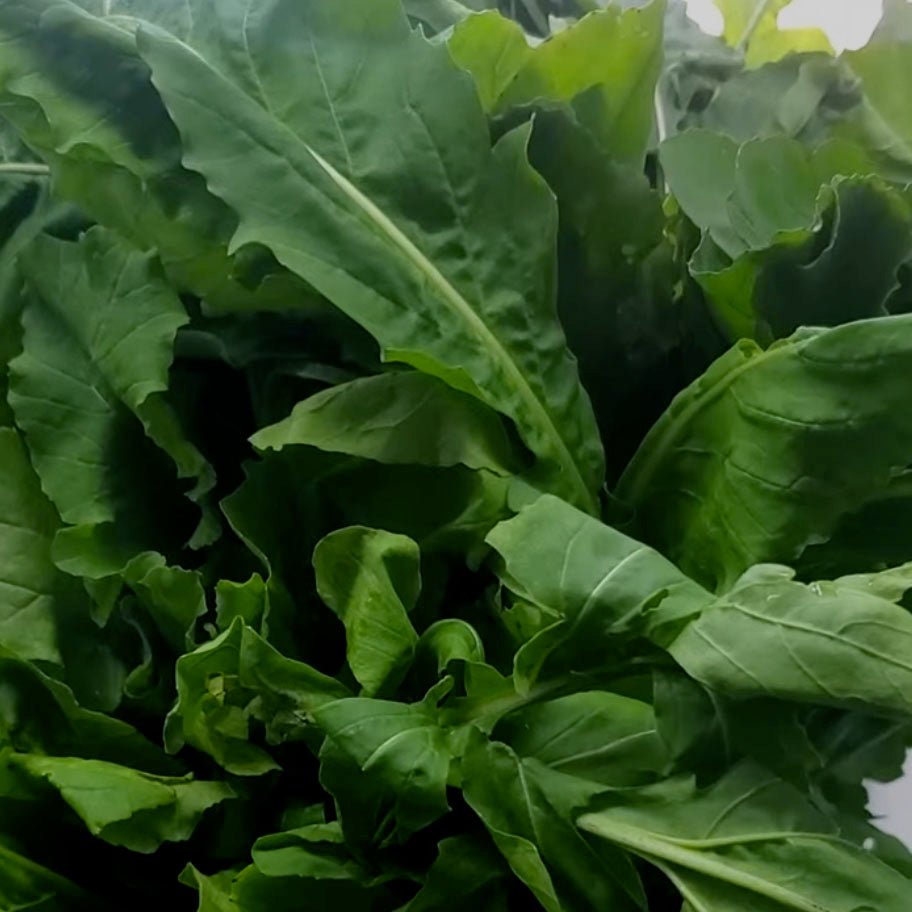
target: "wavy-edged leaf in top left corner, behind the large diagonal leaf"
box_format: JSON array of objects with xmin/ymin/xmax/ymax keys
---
[{"xmin": 0, "ymin": 0, "xmax": 302, "ymax": 310}]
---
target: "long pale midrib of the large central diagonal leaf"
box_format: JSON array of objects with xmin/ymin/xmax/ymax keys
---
[{"xmin": 305, "ymin": 145, "xmax": 598, "ymax": 515}]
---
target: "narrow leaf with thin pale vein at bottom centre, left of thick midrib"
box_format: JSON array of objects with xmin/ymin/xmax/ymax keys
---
[{"xmin": 462, "ymin": 737, "xmax": 646, "ymax": 912}]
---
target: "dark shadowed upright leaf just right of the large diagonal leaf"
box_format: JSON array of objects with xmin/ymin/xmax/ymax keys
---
[{"xmin": 529, "ymin": 110, "xmax": 664, "ymax": 477}]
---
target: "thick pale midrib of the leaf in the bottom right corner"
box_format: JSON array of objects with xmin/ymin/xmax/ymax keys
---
[{"xmin": 577, "ymin": 814, "xmax": 832, "ymax": 912}]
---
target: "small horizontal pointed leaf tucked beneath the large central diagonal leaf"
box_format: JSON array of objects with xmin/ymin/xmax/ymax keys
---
[{"xmin": 251, "ymin": 371, "xmax": 519, "ymax": 475}]
